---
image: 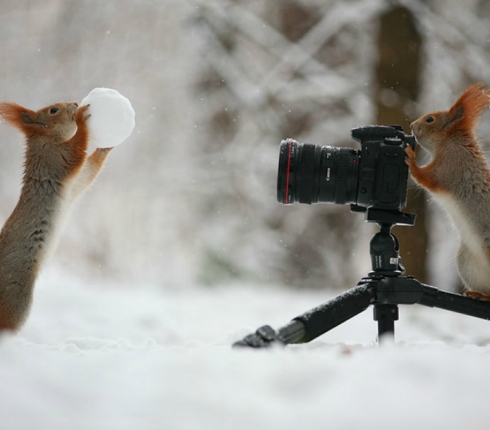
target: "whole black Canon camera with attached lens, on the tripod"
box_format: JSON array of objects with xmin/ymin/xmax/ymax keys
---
[{"xmin": 277, "ymin": 125, "xmax": 415, "ymax": 217}]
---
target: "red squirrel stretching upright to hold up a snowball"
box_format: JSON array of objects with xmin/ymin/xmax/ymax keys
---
[{"xmin": 0, "ymin": 102, "xmax": 112, "ymax": 331}]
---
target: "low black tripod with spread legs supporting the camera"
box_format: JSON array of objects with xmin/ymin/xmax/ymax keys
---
[{"xmin": 233, "ymin": 209, "xmax": 490, "ymax": 348}]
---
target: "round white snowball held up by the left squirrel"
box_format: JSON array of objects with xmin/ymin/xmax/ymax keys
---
[{"xmin": 80, "ymin": 88, "xmax": 135, "ymax": 148}]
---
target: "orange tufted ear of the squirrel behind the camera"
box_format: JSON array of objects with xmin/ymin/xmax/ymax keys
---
[{"xmin": 448, "ymin": 82, "xmax": 490, "ymax": 131}]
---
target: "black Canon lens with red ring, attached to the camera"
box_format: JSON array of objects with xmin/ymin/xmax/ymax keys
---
[{"xmin": 277, "ymin": 139, "xmax": 360, "ymax": 204}]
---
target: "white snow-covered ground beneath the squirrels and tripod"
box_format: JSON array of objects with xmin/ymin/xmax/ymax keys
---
[{"xmin": 0, "ymin": 271, "xmax": 490, "ymax": 430}]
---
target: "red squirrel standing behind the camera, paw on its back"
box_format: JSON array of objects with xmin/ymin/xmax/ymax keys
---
[{"xmin": 406, "ymin": 83, "xmax": 490, "ymax": 300}]
